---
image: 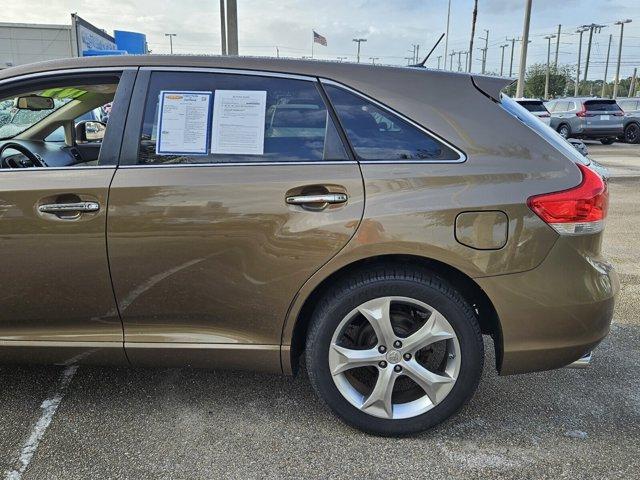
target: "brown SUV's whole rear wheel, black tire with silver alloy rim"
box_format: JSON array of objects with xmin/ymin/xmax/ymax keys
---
[{"xmin": 306, "ymin": 265, "xmax": 484, "ymax": 436}]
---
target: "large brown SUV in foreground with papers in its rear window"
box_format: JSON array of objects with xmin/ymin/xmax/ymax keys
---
[{"xmin": 0, "ymin": 56, "xmax": 619, "ymax": 435}]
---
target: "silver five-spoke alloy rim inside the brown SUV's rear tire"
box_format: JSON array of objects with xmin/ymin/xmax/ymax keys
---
[{"xmin": 328, "ymin": 297, "xmax": 461, "ymax": 419}]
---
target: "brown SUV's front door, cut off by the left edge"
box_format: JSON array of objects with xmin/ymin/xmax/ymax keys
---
[{"xmin": 0, "ymin": 70, "xmax": 135, "ymax": 363}]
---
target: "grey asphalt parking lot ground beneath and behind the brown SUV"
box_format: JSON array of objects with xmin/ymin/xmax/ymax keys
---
[{"xmin": 0, "ymin": 143, "xmax": 640, "ymax": 479}]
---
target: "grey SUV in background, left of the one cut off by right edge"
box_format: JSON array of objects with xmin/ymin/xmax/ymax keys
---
[{"xmin": 547, "ymin": 97, "xmax": 624, "ymax": 145}]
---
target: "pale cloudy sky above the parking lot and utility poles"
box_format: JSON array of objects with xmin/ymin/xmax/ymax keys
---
[{"xmin": 0, "ymin": 0, "xmax": 640, "ymax": 80}]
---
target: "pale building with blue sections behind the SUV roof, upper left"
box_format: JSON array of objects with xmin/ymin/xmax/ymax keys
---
[{"xmin": 0, "ymin": 14, "xmax": 147, "ymax": 69}]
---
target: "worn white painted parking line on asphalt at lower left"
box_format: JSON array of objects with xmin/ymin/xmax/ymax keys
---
[{"xmin": 4, "ymin": 365, "xmax": 78, "ymax": 480}]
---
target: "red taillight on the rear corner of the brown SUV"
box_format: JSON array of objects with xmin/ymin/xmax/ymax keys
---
[{"xmin": 527, "ymin": 165, "xmax": 609, "ymax": 235}]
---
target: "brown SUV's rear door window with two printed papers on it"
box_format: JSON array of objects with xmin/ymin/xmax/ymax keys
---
[{"xmin": 138, "ymin": 72, "xmax": 348, "ymax": 164}]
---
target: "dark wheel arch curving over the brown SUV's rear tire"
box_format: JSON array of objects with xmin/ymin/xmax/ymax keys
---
[{"xmin": 282, "ymin": 254, "xmax": 503, "ymax": 375}]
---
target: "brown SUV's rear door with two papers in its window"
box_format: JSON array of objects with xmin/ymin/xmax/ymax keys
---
[{"xmin": 108, "ymin": 69, "xmax": 364, "ymax": 371}]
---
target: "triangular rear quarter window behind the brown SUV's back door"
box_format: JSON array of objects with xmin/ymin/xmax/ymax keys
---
[{"xmin": 325, "ymin": 85, "xmax": 460, "ymax": 161}]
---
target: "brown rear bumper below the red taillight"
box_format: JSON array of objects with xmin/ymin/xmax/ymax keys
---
[{"xmin": 476, "ymin": 235, "xmax": 620, "ymax": 375}]
